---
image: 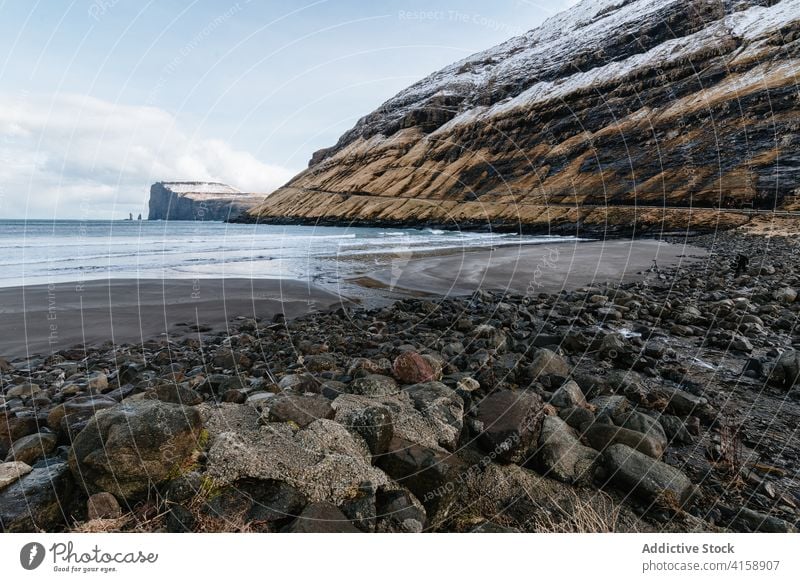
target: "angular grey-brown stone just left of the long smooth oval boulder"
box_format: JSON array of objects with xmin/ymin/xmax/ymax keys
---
[{"xmin": 535, "ymin": 416, "xmax": 599, "ymax": 483}]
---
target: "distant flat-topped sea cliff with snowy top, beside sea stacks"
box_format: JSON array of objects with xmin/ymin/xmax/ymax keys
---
[{"xmin": 147, "ymin": 182, "xmax": 264, "ymax": 220}]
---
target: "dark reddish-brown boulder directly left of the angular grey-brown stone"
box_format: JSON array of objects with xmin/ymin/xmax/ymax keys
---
[{"xmin": 477, "ymin": 390, "xmax": 544, "ymax": 463}]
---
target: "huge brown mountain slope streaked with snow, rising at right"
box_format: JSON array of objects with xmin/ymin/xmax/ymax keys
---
[{"xmin": 251, "ymin": 0, "xmax": 800, "ymax": 233}]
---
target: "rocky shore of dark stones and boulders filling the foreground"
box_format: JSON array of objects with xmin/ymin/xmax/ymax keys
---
[{"xmin": 0, "ymin": 232, "xmax": 800, "ymax": 532}]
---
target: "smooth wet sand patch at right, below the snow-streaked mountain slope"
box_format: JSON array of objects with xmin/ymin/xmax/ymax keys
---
[{"xmin": 362, "ymin": 240, "xmax": 707, "ymax": 295}]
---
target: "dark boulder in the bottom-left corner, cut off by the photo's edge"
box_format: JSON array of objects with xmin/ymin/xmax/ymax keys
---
[{"xmin": 0, "ymin": 461, "xmax": 74, "ymax": 533}]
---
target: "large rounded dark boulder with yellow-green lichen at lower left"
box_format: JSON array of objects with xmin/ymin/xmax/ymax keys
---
[{"xmin": 69, "ymin": 400, "xmax": 201, "ymax": 501}]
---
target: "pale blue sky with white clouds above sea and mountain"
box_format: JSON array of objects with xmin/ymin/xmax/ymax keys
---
[{"xmin": 0, "ymin": 0, "xmax": 576, "ymax": 219}]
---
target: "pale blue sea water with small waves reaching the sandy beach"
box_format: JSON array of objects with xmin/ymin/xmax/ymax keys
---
[{"xmin": 0, "ymin": 220, "xmax": 575, "ymax": 294}]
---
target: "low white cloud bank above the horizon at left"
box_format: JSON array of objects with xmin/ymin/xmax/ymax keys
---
[{"xmin": 0, "ymin": 94, "xmax": 294, "ymax": 218}]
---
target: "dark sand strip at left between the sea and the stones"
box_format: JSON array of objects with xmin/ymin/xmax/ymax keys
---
[{"xmin": 0, "ymin": 279, "xmax": 341, "ymax": 358}]
